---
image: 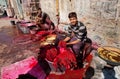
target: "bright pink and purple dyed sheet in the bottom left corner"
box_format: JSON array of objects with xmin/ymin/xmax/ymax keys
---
[{"xmin": 1, "ymin": 56, "xmax": 46, "ymax": 79}]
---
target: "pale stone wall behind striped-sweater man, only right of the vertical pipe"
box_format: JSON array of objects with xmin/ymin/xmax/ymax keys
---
[{"xmin": 59, "ymin": 0, "xmax": 120, "ymax": 21}]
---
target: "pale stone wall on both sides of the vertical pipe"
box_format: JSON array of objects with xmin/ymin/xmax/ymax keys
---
[{"xmin": 41, "ymin": 0, "xmax": 120, "ymax": 21}]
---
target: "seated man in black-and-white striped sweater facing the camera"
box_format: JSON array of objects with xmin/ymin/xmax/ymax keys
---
[{"xmin": 64, "ymin": 12, "xmax": 87, "ymax": 67}]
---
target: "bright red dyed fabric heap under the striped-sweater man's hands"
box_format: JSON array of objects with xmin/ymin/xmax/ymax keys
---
[{"xmin": 54, "ymin": 41, "xmax": 76, "ymax": 69}]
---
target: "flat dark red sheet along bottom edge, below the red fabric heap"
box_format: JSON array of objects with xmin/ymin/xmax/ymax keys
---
[{"xmin": 47, "ymin": 54, "xmax": 93, "ymax": 79}]
